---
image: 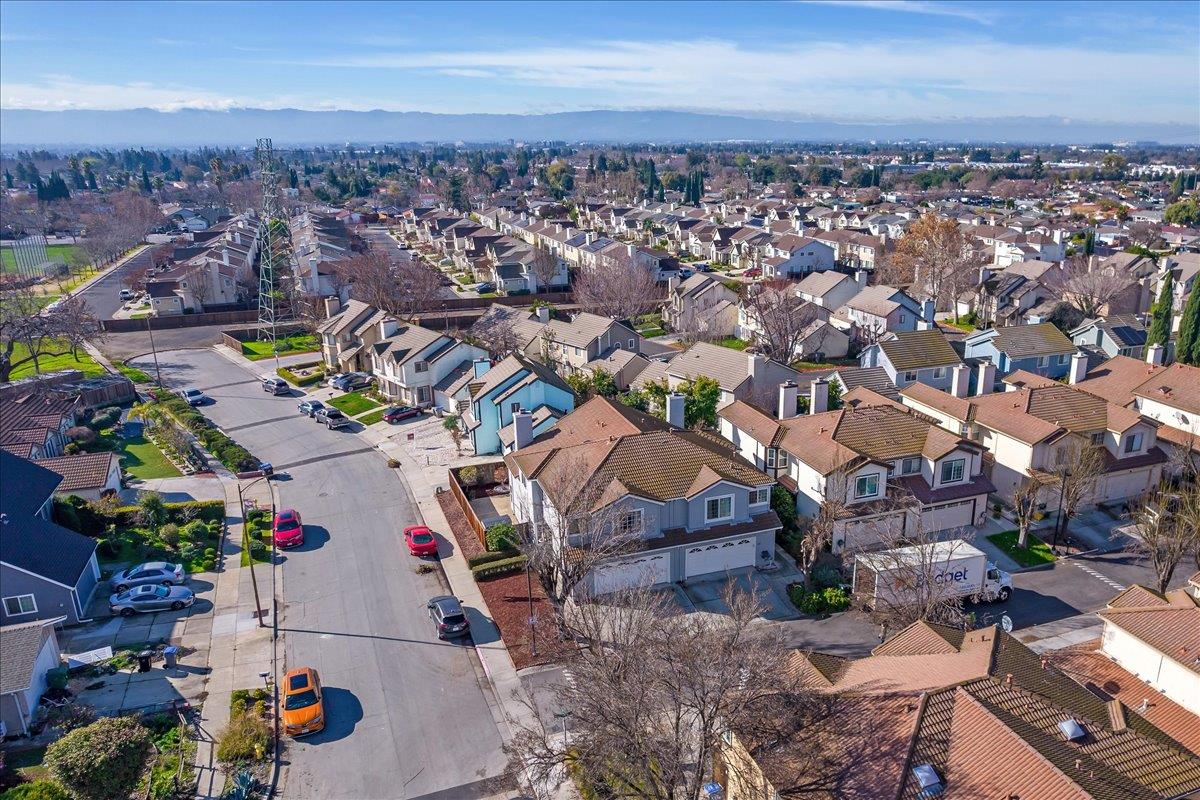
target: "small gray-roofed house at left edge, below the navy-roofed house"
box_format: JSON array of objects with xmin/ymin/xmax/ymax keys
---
[{"xmin": 0, "ymin": 616, "xmax": 62, "ymax": 738}]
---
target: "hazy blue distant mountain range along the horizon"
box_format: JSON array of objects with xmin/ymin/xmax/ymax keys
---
[{"xmin": 0, "ymin": 108, "xmax": 1200, "ymax": 150}]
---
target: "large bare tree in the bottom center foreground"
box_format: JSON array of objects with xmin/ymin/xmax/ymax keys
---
[{"xmin": 505, "ymin": 582, "xmax": 804, "ymax": 800}]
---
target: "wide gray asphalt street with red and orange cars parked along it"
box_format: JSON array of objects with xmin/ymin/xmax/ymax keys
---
[{"xmin": 136, "ymin": 350, "xmax": 504, "ymax": 800}]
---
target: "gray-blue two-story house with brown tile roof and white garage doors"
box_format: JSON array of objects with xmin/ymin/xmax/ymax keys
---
[{"xmin": 504, "ymin": 396, "xmax": 780, "ymax": 595}]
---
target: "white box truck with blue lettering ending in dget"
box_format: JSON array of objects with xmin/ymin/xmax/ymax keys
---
[{"xmin": 852, "ymin": 539, "xmax": 1013, "ymax": 608}]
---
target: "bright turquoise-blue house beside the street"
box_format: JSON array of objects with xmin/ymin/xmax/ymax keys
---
[{"xmin": 462, "ymin": 354, "xmax": 575, "ymax": 456}]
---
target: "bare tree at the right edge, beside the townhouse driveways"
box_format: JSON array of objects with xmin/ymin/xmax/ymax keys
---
[{"xmin": 1129, "ymin": 485, "xmax": 1200, "ymax": 593}]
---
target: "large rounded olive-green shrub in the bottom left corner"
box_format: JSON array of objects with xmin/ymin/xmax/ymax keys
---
[{"xmin": 44, "ymin": 717, "xmax": 150, "ymax": 800}]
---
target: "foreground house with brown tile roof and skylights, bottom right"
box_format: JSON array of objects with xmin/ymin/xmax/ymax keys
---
[{"xmin": 713, "ymin": 621, "xmax": 1200, "ymax": 800}]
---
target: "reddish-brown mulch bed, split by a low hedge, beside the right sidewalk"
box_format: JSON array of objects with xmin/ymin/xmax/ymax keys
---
[{"xmin": 438, "ymin": 492, "xmax": 569, "ymax": 669}]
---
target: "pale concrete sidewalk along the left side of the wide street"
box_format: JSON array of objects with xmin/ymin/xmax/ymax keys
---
[{"xmin": 190, "ymin": 479, "xmax": 282, "ymax": 799}]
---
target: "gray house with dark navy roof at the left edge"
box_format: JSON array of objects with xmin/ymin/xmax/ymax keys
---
[{"xmin": 0, "ymin": 451, "xmax": 100, "ymax": 625}]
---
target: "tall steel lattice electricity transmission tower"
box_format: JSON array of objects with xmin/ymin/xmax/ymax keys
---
[{"xmin": 254, "ymin": 139, "xmax": 295, "ymax": 351}]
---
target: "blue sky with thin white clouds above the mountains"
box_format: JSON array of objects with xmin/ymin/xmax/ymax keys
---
[{"xmin": 0, "ymin": 0, "xmax": 1200, "ymax": 124}]
